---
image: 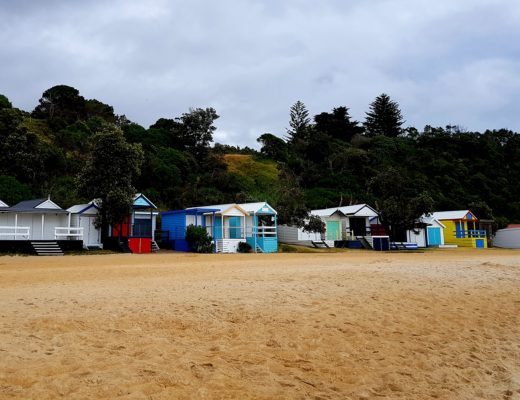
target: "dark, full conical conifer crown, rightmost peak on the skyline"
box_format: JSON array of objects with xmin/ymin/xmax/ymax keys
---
[{"xmin": 363, "ymin": 93, "xmax": 404, "ymax": 137}]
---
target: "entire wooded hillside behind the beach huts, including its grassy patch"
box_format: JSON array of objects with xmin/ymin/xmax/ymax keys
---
[{"xmin": 0, "ymin": 85, "xmax": 520, "ymax": 231}]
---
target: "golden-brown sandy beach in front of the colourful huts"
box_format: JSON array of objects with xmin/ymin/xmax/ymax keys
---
[{"xmin": 0, "ymin": 249, "xmax": 520, "ymax": 400}]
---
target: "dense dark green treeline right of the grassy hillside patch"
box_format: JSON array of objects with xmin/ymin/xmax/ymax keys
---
[{"xmin": 260, "ymin": 98, "xmax": 520, "ymax": 229}]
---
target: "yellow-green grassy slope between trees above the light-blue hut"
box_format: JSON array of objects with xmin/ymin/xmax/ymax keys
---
[{"xmin": 224, "ymin": 154, "xmax": 278, "ymax": 203}]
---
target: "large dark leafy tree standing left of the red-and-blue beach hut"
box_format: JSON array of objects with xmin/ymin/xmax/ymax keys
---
[{"xmin": 78, "ymin": 126, "xmax": 144, "ymax": 241}]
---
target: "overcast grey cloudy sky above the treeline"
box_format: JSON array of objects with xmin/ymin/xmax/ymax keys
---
[{"xmin": 0, "ymin": 0, "xmax": 520, "ymax": 147}]
